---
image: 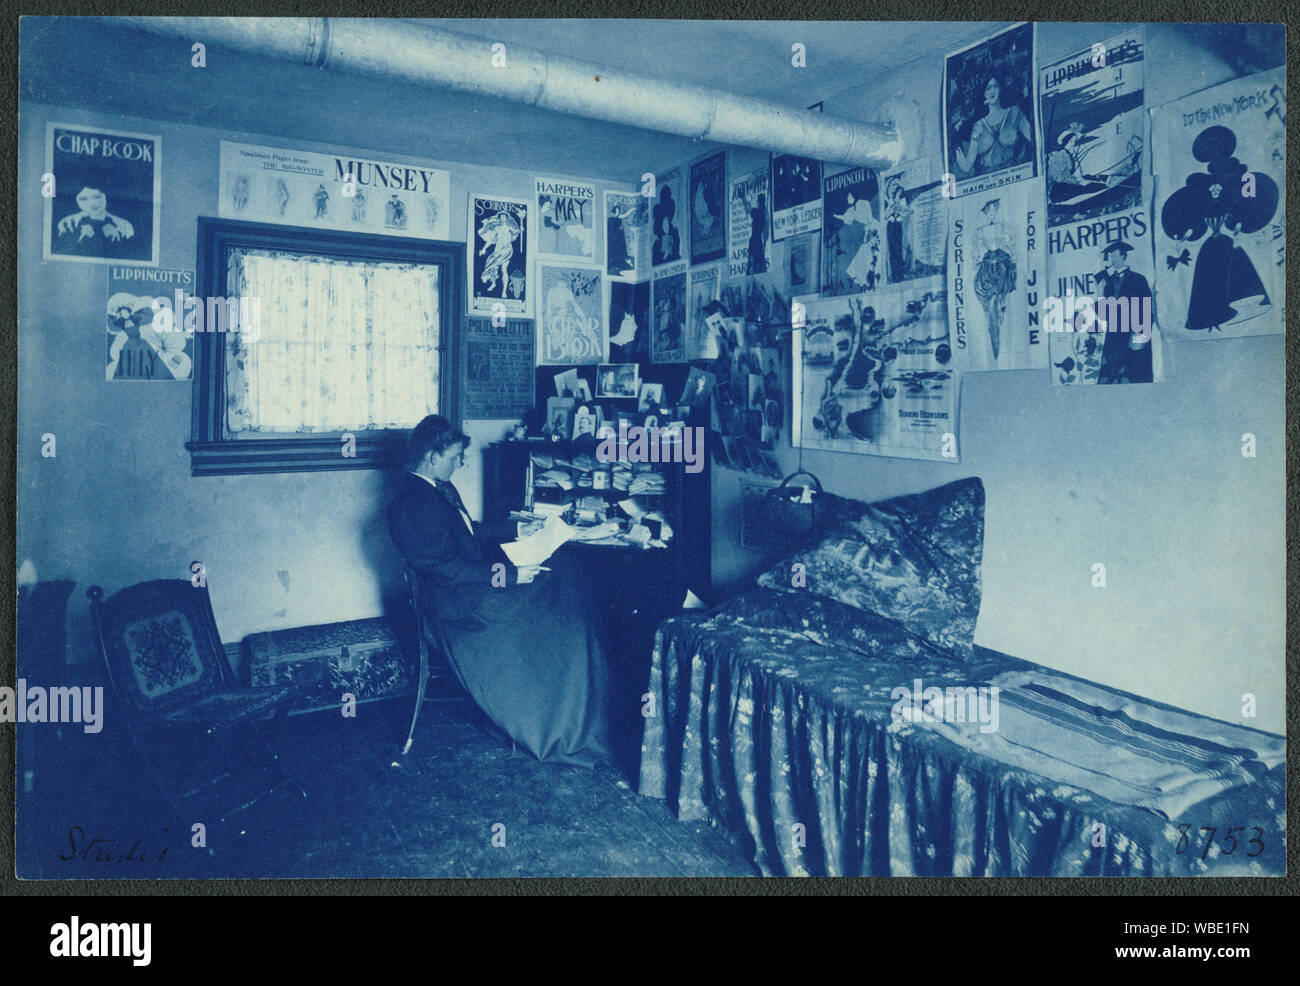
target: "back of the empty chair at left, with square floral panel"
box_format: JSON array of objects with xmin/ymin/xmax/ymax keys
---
[{"xmin": 86, "ymin": 579, "xmax": 238, "ymax": 718}]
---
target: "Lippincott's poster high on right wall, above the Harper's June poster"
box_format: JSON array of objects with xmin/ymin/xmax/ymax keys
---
[{"xmin": 1039, "ymin": 27, "xmax": 1147, "ymax": 226}]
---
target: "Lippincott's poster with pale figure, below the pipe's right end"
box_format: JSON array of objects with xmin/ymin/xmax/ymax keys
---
[{"xmin": 822, "ymin": 168, "xmax": 884, "ymax": 298}]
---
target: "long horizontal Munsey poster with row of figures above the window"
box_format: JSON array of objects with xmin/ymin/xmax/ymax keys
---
[{"xmin": 217, "ymin": 140, "xmax": 451, "ymax": 239}]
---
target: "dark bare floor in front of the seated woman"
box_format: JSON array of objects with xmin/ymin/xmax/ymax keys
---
[{"xmin": 20, "ymin": 701, "xmax": 757, "ymax": 879}]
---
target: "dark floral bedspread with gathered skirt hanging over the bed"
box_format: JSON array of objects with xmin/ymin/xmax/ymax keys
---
[{"xmin": 640, "ymin": 588, "xmax": 1286, "ymax": 877}]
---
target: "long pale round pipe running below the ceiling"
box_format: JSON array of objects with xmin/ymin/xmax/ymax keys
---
[{"xmin": 105, "ymin": 17, "xmax": 904, "ymax": 170}]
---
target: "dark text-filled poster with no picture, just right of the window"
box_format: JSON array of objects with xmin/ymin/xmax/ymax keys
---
[{"xmin": 460, "ymin": 317, "xmax": 534, "ymax": 420}]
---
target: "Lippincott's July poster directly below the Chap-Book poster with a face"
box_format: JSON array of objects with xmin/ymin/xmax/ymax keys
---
[{"xmin": 105, "ymin": 265, "xmax": 198, "ymax": 381}]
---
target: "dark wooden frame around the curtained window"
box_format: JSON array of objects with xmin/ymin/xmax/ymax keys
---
[{"xmin": 185, "ymin": 216, "xmax": 465, "ymax": 476}]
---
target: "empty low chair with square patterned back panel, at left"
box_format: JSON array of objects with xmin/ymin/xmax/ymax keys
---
[{"xmin": 86, "ymin": 579, "xmax": 307, "ymax": 823}]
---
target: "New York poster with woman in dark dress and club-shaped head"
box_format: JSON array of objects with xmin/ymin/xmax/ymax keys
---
[{"xmin": 1151, "ymin": 68, "xmax": 1287, "ymax": 340}]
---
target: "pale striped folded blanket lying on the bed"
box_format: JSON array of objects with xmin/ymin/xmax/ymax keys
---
[{"xmin": 917, "ymin": 671, "xmax": 1286, "ymax": 818}]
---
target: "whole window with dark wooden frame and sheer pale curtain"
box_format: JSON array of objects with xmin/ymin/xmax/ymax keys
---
[{"xmin": 186, "ymin": 219, "xmax": 464, "ymax": 476}]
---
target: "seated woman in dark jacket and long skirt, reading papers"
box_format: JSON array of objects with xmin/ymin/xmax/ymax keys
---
[{"xmin": 389, "ymin": 415, "xmax": 610, "ymax": 766}]
